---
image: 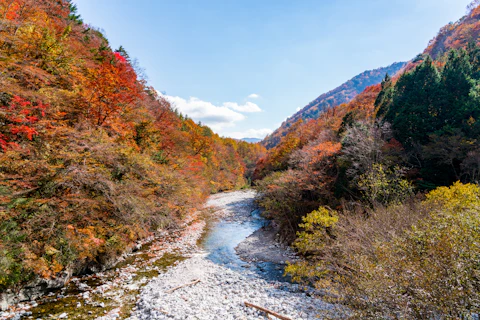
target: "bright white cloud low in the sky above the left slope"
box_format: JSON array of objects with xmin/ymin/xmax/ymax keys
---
[{"xmin": 162, "ymin": 95, "xmax": 246, "ymax": 132}]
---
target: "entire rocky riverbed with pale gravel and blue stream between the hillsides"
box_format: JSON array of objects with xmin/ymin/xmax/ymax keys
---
[{"xmin": 0, "ymin": 190, "xmax": 340, "ymax": 320}]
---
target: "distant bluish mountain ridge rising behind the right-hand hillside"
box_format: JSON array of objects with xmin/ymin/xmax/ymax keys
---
[{"xmin": 262, "ymin": 62, "xmax": 407, "ymax": 149}]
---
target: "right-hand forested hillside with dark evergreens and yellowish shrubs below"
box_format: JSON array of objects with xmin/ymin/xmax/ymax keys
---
[{"xmin": 254, "ymin": 2, "xmax": 480, "ymax": 319}]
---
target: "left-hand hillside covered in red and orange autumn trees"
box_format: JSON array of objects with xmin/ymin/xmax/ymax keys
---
[{"xmin": 0, "ymin": 0, "xmax": 264, "ymax": 292}]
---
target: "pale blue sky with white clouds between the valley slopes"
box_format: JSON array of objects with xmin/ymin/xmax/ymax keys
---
[{"xmin": 74, "ymin": 0, "xmax": 471, "ymax": 138}]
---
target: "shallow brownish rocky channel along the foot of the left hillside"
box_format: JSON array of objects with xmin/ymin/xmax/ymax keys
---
[{"xmin": 0, "ymin": 204, "xmax": 204, "ymax": 320}]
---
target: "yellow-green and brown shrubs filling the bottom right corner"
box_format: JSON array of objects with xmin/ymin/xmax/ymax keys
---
[{"xmin": 287, "ymin": 183, "xmax": 480, "ymax": 319}]
